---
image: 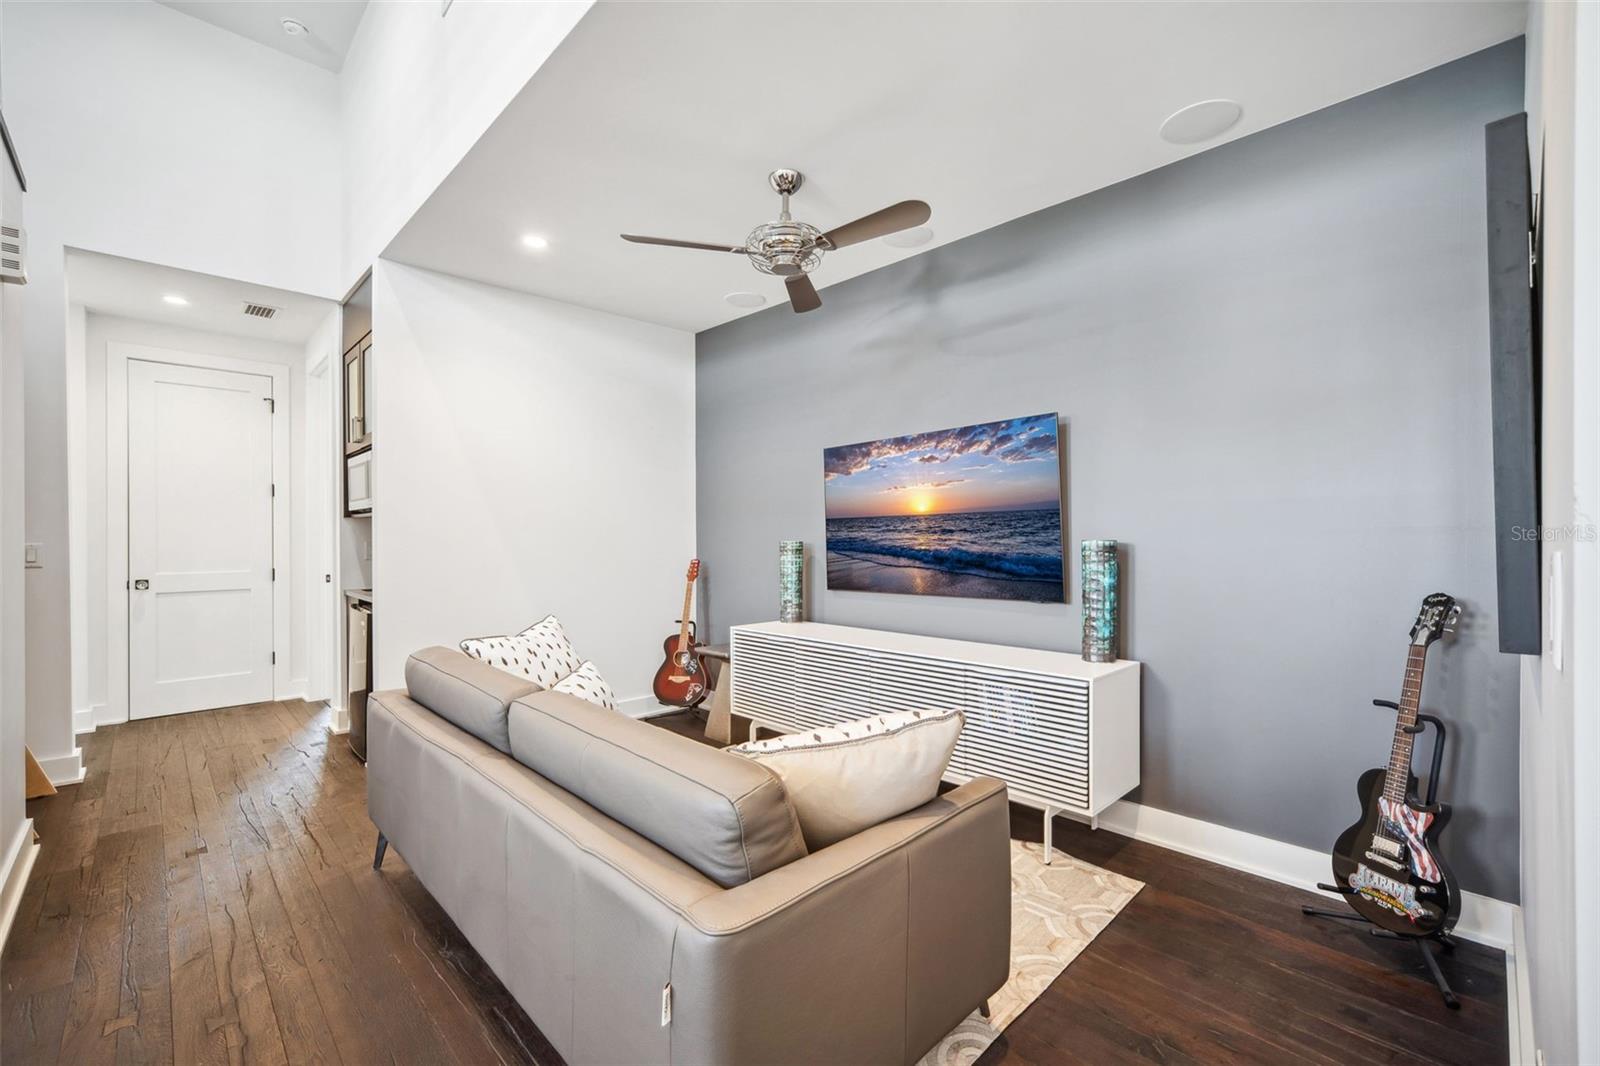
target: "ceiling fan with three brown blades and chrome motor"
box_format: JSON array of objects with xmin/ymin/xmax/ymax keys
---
[{"xmin": 622, "ymin": 170, "xmax": 933, "ymax": 314}]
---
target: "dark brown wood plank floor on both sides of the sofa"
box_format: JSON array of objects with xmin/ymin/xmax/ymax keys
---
[{"xmin": 0, "ymin": 703, "xmax": 1506, "ymax": 1066}]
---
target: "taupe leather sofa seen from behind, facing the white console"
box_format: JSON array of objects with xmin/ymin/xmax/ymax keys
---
[{"xmin": 366, "ymin": 648, "xmax": 1011, "ymax": 1064}]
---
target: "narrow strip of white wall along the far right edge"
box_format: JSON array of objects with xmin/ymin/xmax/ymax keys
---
[{"xmin": 1522, "ymin": 3, "xmax": 1600, "ymax": 1063}]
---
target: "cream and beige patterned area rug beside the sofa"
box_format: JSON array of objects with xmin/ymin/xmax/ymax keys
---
[{"xmin": 918, "ymin": 840, "xmax": 1144, "ymax": 1066}]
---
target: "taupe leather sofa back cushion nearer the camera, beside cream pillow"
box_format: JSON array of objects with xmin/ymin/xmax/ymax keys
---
[{"xmin": 510, "ymin": 691, "xmax": 806, "ymax": 888}]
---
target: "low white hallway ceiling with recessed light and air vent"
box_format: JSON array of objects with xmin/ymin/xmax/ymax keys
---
[{"xmin": 67, "ymin": 250, "xmax": 338, "ymax": 344}]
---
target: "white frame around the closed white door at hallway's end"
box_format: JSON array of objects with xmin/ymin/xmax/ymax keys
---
[{"xmin": 106, "ymin": 341, "xmax": 296, "ymax": 722}]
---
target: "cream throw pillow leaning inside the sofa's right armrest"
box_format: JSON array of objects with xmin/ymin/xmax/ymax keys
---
[{"xmin": 728, "ymin": 709, "xmax": 965, "ymax": 852}]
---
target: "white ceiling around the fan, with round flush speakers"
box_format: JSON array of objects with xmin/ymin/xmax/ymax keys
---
[{"xmin": 386, "ymin": 0, "xmax": 1526, "ymax": 331}]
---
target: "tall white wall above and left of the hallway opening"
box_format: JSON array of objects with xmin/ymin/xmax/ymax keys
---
[{"xmin": 0, "ymin": 0, "xmax": 341, "ymax": 768}]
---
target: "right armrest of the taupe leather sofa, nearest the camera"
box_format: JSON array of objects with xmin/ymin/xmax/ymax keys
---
[{"xmin": 672, "ymin": 778, "xmax": 1011, "ymax": 1063}]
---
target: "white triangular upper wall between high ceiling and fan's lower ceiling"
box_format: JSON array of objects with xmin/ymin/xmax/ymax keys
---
[{"xmin": 339, "ymin": 0, "xmax": 592, "ymax": 285}]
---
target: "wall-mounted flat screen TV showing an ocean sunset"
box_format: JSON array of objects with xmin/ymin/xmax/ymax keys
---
[{"xmin": 822, "ymin": 415, "xmax": 1066, "ymax": 603}]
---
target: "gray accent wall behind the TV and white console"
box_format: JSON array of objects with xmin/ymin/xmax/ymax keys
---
[{"xmin": 696, "ymin": 38, "xmax": 1523, "ymax": 901}]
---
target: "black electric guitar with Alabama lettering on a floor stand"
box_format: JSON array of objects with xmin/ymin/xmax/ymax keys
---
[{"xmin": 1333, "ymin": 592, "xmax": 1461, "ymax": 936}]
